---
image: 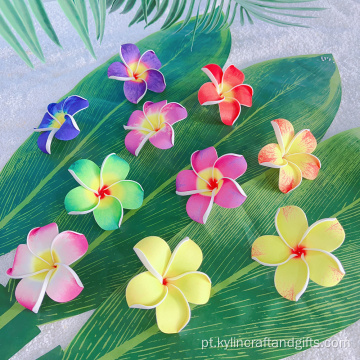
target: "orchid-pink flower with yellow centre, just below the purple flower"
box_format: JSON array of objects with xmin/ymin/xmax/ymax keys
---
[{"xmin": 124, "ymin": 100, "xmax": 187, "ymax": 156}]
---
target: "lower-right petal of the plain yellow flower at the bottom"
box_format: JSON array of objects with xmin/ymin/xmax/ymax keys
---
[{"xmin": 167, "ymin": 271, "xmax": 211, "ymax": 305}]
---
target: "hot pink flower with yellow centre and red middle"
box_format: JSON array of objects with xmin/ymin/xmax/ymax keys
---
[{"xmin": 176, "ymin": 147, "xmax": 247, "ymax": 224}]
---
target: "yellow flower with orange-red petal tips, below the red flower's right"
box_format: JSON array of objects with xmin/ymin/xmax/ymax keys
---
[{"xmin": 258, "ymin": 119, "xmax": 321, "ymax": 194}]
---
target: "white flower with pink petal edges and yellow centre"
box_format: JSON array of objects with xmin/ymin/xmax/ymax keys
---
[{"xmin": 7, "ymin": 223, "xmax": 88, "ymax": 313}]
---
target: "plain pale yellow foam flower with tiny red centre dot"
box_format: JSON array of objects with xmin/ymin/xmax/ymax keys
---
[{"xmin": 126, "ymin": 236, "xmax": 211, "ymax": 334}]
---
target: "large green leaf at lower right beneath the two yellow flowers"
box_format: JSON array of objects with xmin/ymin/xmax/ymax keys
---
[{"xmin": 63, "ymin": 128, "xmax": 360, "ymax": 360}]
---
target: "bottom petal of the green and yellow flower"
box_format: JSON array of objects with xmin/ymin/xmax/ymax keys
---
[{"xmin": 94, "ymin": 196, "xmax": 123, "ymax": 230}]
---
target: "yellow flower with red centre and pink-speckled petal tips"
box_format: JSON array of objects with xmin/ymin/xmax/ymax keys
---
[{"xmin": 251, "ymin": 206, "xmax": 345, "ymax": 301}]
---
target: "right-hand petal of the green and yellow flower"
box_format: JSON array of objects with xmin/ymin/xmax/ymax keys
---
[{"xmin": 108, "ymin": 180, "xmax": 144, "ymax": 209}]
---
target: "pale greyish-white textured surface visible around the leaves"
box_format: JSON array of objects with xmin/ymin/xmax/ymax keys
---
[{"xmin": 0, "ymin": 0, "xmax": 360, "ymax": 360}]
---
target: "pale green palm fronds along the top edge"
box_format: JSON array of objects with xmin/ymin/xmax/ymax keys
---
[{"xmin": 0, "ymin": 0, "xmax": 324, "ymax": 67}]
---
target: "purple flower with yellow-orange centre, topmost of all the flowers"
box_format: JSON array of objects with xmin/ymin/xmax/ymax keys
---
[{"xmin": 108, "ymin": 44, "xmax": 166, "ymax": 104}]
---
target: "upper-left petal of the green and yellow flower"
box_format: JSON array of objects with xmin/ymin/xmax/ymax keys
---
[{"xmin": 69, "ymin": 159, "xmax": 100, "ymax": 193}]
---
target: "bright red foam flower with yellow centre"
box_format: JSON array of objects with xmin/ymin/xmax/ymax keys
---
[{"xmin": 198, "ymin": 64, "xmax": 253, "ymax": 125}]
